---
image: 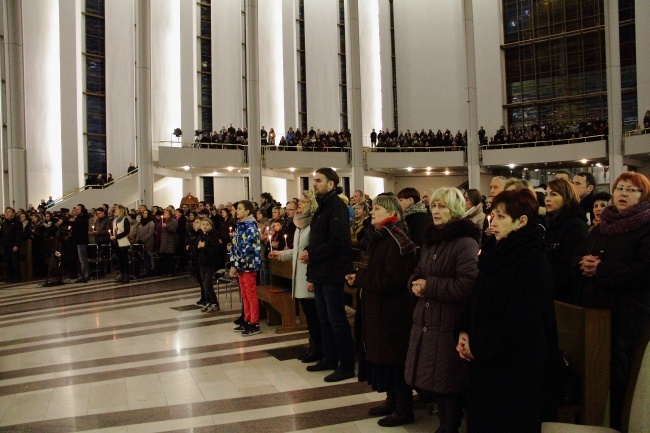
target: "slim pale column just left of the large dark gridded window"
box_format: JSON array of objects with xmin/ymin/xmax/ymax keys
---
[{"xmin": 463, "ymin": 0, "xmax": 481, "ymax": 190}]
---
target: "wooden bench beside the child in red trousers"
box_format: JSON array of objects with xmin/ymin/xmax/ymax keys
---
[{"xmin": 257, "ymin": 260, "xmax": 307, "ymax": 334}]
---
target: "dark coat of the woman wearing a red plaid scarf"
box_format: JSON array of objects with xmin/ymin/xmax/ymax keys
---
[{"xmin": 355, "ymin": 219, "xmax": 415, "ymax": 366}]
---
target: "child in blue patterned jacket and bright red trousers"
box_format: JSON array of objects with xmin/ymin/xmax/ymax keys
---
[{"xmin": 230, "ymin": 200, "xmax": 261, "ymax": 336}]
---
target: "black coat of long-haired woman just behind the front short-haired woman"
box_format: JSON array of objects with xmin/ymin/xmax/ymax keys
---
[{"xmin": 546, "ymin": 206, "xmax": 589, "ymax": 305}]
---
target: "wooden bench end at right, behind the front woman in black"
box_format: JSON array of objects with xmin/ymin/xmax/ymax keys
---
[{"xmin": 555, "ymin": 302, "xmax": 611, "ymax": 425}]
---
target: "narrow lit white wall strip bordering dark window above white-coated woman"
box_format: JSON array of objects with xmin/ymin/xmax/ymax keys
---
[{"xmin": 275, "ymin": 0, "xmax": 298, "ymax": 131}]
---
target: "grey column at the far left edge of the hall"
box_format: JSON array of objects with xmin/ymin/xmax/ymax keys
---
[{"xmin": 0, "ymin": 0, "xmax": 27, "ymax": 210}]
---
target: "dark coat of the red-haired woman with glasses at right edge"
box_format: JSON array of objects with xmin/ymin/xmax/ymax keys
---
[{"xmin": 579, "ymin": 221, "xmax": 650, "ymax": 394}]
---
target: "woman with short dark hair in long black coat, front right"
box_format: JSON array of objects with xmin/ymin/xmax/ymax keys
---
[{"xmin": 456, "ymin": 189, "xmax": 558, "ymax": 433}]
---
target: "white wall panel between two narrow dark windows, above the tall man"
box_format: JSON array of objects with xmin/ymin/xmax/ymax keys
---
[{"xmin": 305, "ymin": 0, "xmax": 341, "ymax": 131}]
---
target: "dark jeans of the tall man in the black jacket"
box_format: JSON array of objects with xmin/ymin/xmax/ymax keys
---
[{"xmin": 314, "ymin": 283, "xmax": 354, "ymax": 373}]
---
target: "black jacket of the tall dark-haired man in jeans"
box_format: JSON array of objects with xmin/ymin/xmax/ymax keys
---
[{"xmin": 307, "ymin": 189, "xmax": 352, "ymax": 284}]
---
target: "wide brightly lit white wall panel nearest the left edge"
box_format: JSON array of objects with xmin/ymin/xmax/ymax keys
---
[{"xmin": 22, "ymin": 0, "xmax": 62, "ymax": 207}]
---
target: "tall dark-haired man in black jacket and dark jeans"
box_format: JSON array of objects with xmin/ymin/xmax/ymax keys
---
[{"xmin": 298, "ymin": 168, "xmax": 354, "ymax": 382}]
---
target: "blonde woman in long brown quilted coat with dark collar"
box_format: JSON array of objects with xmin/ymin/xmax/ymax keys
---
[{"xmin": 405, "ymin": 187, "xmax": 481, "ymax": 433}]
